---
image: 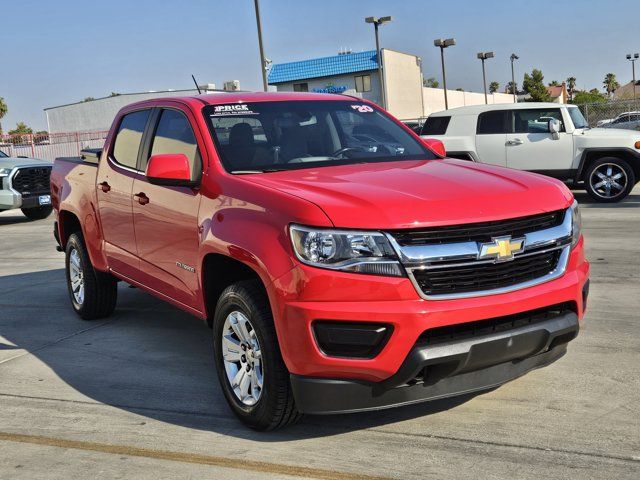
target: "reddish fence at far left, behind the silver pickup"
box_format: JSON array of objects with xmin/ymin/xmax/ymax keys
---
[{"xmin": 0, "ymin": 131, "xmax": 109, "ymax": 161}]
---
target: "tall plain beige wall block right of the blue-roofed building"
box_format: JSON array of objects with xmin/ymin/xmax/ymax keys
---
[{"xmin": 382, "ymin": 48, "xmax": 422, "ymax": 119}]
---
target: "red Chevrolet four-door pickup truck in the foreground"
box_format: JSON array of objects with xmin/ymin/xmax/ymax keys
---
[{"xmin": 51, "ymin": 93, "xmax": 589, "ymax": 429}]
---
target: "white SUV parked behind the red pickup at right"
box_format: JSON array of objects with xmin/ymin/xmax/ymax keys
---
[{"xmin": 421, "ymin": 103, "xmax": 640, "ymax": 202}]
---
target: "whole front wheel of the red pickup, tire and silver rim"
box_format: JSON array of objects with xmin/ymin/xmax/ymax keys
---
[{"xmin": 213, "ymin": 281, "xmax": 301, "ymax": 430}]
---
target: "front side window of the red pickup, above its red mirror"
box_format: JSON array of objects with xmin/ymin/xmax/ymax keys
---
[{"xmin": 149, "ymin": 109, "xmax": 201, "ymax": 178}]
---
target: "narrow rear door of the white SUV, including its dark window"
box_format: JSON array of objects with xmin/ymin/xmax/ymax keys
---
[{"xmin": 476, "ymin": 110, "xmax": 511, "ymax": 167}]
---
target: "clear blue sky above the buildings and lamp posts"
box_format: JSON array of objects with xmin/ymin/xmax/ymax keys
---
[{"xmin": 0, "ymin": 0, "xmax": 640, "ymax": 131}]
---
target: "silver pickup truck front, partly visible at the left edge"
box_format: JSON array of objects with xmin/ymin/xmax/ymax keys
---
[{"xmin": 0, "ymin": 150, "xmax": 53, "ymax": 220}]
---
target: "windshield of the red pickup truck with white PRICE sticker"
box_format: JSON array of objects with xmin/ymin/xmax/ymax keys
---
[{"xmin": 204, "ymin": 100, "xmax": 436, "ymax": 173}]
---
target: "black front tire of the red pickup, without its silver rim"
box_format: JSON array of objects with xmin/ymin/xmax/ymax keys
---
[{"xmin": 213, "ymin": 280, "xmax": 302, "ymax": 430}]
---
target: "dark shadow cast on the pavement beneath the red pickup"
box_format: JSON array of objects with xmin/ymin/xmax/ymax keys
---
[{"xmin": 0, "ymin": 269, "xmax": 475, "ymax": 442}]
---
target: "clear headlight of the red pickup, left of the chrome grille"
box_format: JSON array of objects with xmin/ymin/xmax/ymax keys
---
[{"xmin": 289, "ymin": 225, "xmax": 404, "ymax": 277}]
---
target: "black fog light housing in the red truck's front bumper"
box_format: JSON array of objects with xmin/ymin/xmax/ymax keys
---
[{"xmin": 313, "ymin": 320, "xmax": 393, "ymax": 359}]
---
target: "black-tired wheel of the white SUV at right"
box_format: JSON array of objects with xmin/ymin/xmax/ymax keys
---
[{"xmin": 585, "ymin": 157, "xmax": 635, "ymax": 203}]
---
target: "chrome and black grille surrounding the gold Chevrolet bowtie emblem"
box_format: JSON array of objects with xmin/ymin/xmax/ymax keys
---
[{"xmin": 387, "ymin": 210, "xmax": 572, "ymax": 300}]
